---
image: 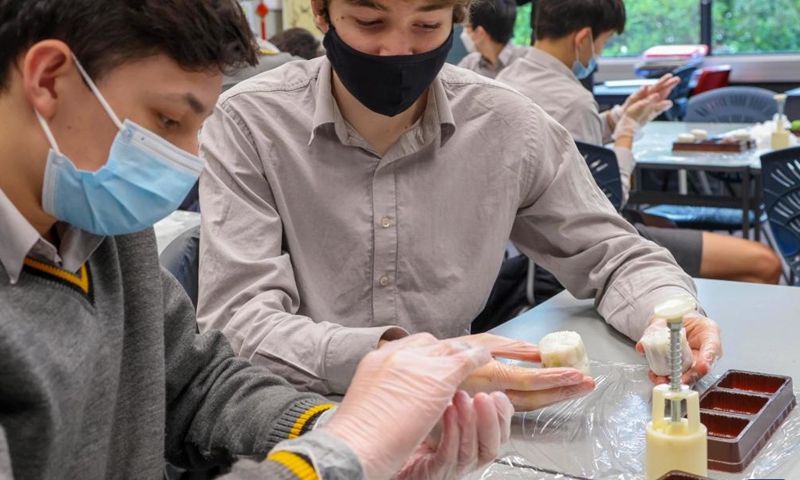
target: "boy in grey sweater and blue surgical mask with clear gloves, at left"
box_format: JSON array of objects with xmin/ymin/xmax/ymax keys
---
[{"xmin": 0, "ymin": 0, "xmax": 513, "ymax": 480}]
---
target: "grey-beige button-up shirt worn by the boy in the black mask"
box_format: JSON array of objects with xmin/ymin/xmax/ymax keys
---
[{"xmin": 198, "ymin": 58, "xmax": 695, "ymax": 393}]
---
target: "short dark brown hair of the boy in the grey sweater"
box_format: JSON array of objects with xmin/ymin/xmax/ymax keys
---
[{"xmin": 0, "ymin": 0, "xmax": 258, "ymax": 92}]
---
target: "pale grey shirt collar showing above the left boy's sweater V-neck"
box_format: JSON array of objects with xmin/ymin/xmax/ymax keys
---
[{"xmin": 0, "ymin": 189, "xmax": 105, "ymax": 284}]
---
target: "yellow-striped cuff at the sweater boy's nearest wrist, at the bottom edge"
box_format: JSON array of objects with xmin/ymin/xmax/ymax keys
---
[{"xmin": 266, "ymin": 430, "xmax": 365, "ymax": 480}]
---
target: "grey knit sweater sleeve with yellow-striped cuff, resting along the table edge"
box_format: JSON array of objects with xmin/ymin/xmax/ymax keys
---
[{"xmin": 161, "ymin": 262, "xmax": 335, "ymax": 469}]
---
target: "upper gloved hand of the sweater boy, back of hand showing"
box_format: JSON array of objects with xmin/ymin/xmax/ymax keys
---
[{"xmin": 321, "ymin": 334, "xmax": 491, "ymax": 480}]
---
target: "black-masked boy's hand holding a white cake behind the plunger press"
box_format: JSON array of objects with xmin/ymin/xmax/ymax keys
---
[{"xmin": 636, "ymin": 313, "xmax": 722, "ymax": 385}]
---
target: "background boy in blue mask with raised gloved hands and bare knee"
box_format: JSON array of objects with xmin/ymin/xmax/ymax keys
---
[{"xmin": 497, "ymin": 0, "xmax": 781, "ymax": 283}]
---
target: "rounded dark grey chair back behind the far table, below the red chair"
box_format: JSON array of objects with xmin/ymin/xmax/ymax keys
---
[{"xmin": 684, "ymin": 87, "xmax": 778, "ymax": 123}]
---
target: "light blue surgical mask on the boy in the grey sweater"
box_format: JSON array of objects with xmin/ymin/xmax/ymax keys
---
[{"xmin": 36, "ymin": 57, "xmax": 204, "ymax": 235}]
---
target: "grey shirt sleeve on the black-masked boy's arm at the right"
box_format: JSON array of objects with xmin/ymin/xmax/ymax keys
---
[{"xmin": 511, "ymin": 105, "xmax": 696, "ymax": 340}]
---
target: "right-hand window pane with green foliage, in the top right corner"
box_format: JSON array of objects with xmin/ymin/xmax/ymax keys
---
[{"xmin": 712, "ymin": 0, "xmax": 800, "ymax": 55}]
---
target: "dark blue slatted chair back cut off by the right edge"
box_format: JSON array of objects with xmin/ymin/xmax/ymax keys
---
[{"xmin": 761, "ymin": 147, "xmax": 800, "ymax": 285}]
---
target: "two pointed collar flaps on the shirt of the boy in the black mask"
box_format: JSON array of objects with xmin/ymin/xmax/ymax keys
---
[{"xmin": 308, "ymin": 59, "xmax": 456, "ymax": 145}]
